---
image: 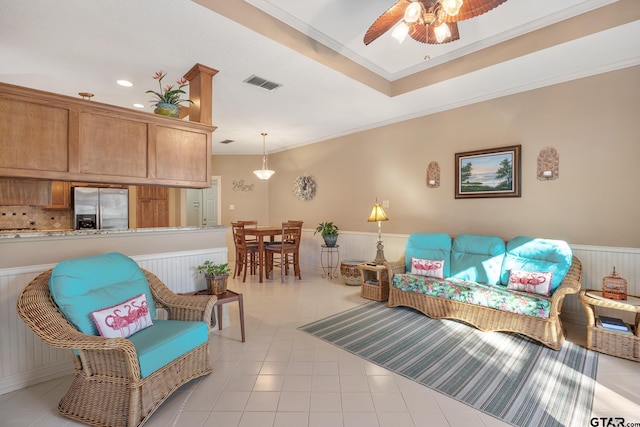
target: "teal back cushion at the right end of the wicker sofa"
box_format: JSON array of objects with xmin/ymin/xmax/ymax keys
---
[{"xmin": 500, "ymin": 236, "xmax": 573, "ymax": 295}]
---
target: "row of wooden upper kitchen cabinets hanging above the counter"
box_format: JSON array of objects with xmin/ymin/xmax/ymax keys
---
[{"xmin": 0, "ymin": 83, "xmax": 215, "ymax": 188}]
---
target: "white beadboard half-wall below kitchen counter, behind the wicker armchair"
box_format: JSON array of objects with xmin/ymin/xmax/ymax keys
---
[{"xmin": 0, "ymin": 248, "xmax": 227, "ymax": 394}]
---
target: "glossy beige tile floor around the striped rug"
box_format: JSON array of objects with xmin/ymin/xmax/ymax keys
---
[{"xmin": 0, "ymin": 271, "xmax": 640, "ymax": 427}]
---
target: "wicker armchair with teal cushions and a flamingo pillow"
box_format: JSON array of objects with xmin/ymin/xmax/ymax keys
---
[{"xmin": 17, "ymin": 253, "xmax": 216, "ymax": 427}]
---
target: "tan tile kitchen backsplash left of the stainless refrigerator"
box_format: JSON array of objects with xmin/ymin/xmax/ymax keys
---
[{"xmin": 0, "ymin": 206, "xmax": 73, "ymax": 230}]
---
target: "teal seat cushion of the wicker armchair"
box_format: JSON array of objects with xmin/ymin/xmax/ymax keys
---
[{"xmin": 128, "ymin": 320, "xmax": 209, "ymax": 378}]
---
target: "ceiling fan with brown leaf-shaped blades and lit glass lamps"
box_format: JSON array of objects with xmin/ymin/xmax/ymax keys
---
[{"xmin": 364, "ymin": 0, "xmax": 507, "ymax": 45}]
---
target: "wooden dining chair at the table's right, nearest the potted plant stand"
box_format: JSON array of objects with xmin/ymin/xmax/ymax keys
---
[{"xmin": 265, "ymin": 221, "xmax": 302, "ymax": 283}]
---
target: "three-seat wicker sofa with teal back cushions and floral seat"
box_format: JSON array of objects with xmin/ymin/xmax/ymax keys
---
[{"xmin": 385, "ymin": 233, "xmax": 582, "ymax": 350}]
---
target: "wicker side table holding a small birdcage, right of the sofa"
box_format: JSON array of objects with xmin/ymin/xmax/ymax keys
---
[{"xmin": 578, "ymin": 289, "xmax": 640, "ymax": 362}]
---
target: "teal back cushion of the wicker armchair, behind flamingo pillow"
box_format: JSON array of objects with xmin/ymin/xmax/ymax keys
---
[{"xmin": 49, "ymin": 252, "xmax": 156, "ymax": 335}]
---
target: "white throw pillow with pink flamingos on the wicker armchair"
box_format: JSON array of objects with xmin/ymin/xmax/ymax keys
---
[{"xmin": 91, "ymin": 294, "xmax": 153, "ymax": 338}]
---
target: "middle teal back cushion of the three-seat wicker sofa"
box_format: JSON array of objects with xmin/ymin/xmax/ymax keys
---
[{"xmin": 445, "ymin": 234, "xmax": 506, "ymax": 285}]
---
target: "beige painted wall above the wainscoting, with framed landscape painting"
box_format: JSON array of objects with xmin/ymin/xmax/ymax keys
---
[{"xmin": 214, "ymin": 67, "xmax": 640, "ymax": 247}]
